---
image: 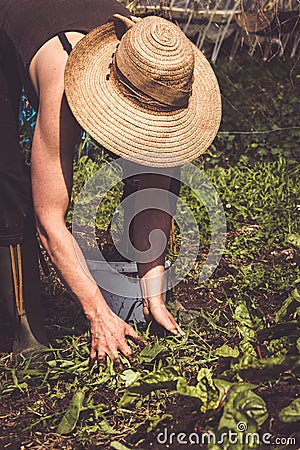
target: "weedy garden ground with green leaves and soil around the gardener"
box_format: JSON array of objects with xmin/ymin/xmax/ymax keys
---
[{"xmin": 0, "ymin": 55, "xmax": 300, "ymax": 450}]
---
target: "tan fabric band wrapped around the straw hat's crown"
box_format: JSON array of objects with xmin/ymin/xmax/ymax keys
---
[{"xmin": 113, "ymin": 49, "xmax": 192, "ymax": 108}]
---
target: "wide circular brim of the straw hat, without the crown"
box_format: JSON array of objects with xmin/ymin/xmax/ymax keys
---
[{"xmin": 65, "ymin": 22, "xmax": 221, "ymax": 167}]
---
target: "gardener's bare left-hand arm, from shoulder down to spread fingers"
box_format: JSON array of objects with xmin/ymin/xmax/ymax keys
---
[{"xmin": 31, "ymin": 33, "xmax": 144, "ymax": 361}]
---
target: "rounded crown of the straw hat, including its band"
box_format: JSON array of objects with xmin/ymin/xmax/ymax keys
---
[{"xmin": 115, "ymin": 17, "xmax": 195, "ymax": 107}]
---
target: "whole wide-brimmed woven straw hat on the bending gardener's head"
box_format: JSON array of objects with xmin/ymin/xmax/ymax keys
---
[{"xmin": 65, "ymin": 15, "xmax": 221, "ymax": 167}]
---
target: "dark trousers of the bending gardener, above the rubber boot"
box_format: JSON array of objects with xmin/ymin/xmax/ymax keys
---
[{"xmin": 0, "ymin": 41, "xmax": 35, "ymax": 246}]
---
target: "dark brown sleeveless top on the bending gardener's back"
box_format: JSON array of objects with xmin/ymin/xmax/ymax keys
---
[{"xmin": 0, "ymin": 0, "xmax": 129, "ymax": 107}]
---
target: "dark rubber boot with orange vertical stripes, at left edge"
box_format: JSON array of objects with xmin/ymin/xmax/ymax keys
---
[{"xmin": 0, "ymin": 239, "xmax": 48, "ymax": 357}]
